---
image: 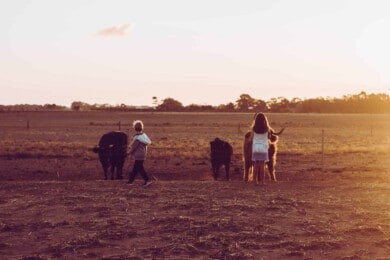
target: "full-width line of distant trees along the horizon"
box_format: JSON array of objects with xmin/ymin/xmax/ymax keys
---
[{"xmin": 0, "ymin": 91, "xmax": 390, "ymax": 114}]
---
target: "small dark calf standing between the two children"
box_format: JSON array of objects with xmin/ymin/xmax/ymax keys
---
[{"xmin": 210, "ymin": 138, "xmax": 233, "ymax": 180}]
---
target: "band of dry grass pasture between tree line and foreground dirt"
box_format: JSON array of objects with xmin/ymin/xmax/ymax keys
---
[{"xmin": 0, "ymin": 112, "xmax": 390, "ymax": 179}]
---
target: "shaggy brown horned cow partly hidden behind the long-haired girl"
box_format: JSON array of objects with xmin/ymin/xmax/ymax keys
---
[{"xmin": 243, "ymin": 128, "xmax": 285, "ymax": 181}]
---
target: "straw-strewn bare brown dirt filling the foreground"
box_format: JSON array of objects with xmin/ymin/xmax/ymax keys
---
[{"xmin": 0, "ymin": 153, "xmax": 390, "ymax": 259}]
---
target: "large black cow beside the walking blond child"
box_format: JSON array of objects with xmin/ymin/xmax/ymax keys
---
[{"xmin": 93, "ymin": 131, "xmax": 127, "ymax": 180}]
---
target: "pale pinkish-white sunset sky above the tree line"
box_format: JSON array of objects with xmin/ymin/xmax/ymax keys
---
[{"xmin": 0, "ymin": 0, "xmax": 390, "ymax": 106}]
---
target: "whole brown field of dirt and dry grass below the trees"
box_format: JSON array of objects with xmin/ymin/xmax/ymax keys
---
[{"xmin": 0, "ymin": 112, "xmax": 390, "ymax": 259}]
